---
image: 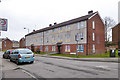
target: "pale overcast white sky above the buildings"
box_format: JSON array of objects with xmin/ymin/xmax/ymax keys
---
[{"xmin": 0, "ymin": 0, "xmax": 120, "ymax": 41}]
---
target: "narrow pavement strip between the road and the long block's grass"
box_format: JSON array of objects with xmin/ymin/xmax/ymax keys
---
[{"xmin": 35, "ymin": 54, "xmax": 120, "ymax": 63}]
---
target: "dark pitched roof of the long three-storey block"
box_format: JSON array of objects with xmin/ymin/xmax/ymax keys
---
[{"xmin": 25, "ymin": 12, "xmax": 98, "ymax": 36}]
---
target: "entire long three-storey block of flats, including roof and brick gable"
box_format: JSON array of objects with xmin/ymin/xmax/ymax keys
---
[{"xmin": 25, "ymin": 11, "xmax": 105, "ymax": 55}]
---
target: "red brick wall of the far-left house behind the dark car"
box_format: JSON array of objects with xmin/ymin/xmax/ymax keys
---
[{"xmin": 2, "ymin": 39, "xmax": 13, "ymax": 51}]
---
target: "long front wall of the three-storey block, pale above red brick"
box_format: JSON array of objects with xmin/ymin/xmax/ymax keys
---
[{"xmin": 26, "ymin": 21, "xmax": 87, "ymax": 53}]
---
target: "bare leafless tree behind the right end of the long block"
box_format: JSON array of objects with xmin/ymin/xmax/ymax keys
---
[{"xmin": 103, "ymin": 17, "xmax": 116, "ymax": 51}]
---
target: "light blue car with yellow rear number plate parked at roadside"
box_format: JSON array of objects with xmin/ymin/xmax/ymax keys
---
[{"xmin": 10, "ymin": 48, "xmax": 35, "ymax": 65}]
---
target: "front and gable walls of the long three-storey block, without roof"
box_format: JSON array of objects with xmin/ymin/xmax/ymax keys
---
[{"xmin": 26, "ymin": 14, "xmax": 105, "ymax": 55}]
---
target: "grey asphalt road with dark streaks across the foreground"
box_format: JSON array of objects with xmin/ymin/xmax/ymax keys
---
[{"xmin": 0, "ymin": 52, "xmax": 118, "ymax": 78}]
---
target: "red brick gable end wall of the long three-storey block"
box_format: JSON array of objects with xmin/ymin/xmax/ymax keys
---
[{"xmin": 87, "ymin": 14, "xmax": 105, "ymax": 55}]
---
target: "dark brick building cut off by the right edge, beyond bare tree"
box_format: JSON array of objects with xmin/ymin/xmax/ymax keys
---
[{"xmin": 112, "ymin": 23, "xmax": 120, "ymax": 49}]
